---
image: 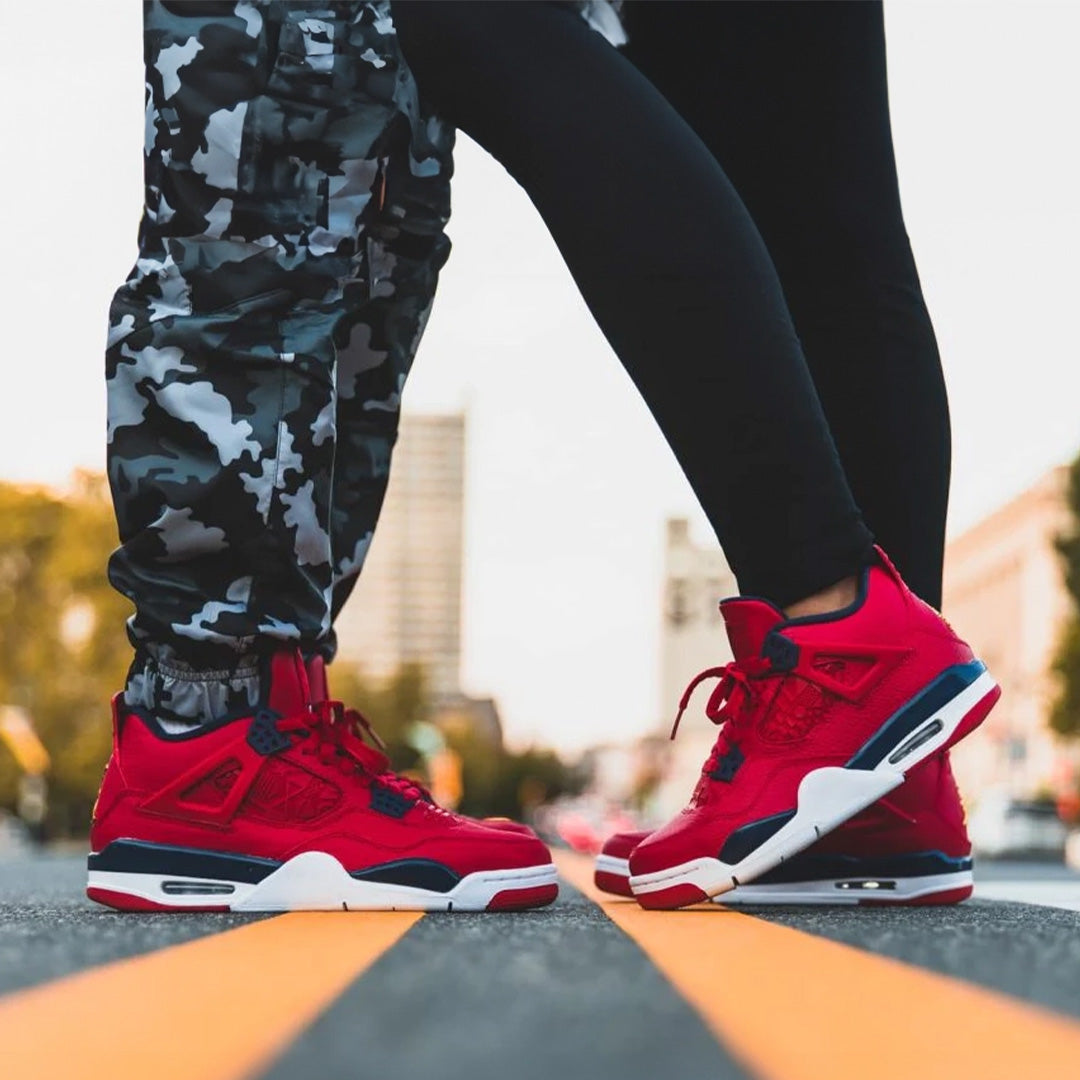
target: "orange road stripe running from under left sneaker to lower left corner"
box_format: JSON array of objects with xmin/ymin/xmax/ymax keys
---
[{"xmin": 0, "ymin": 912, "xmax": 421, "ymax": 1080}]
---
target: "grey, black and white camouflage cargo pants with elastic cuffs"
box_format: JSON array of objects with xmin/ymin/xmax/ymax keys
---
[{"xmin": 106, "ymin": 0, "xmax": 454, "ymax": 715}]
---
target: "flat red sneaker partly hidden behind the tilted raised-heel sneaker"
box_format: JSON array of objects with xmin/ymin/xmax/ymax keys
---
[{"xmin": 594, "ymin": 752, "xmax": 972, "ymax": 904}]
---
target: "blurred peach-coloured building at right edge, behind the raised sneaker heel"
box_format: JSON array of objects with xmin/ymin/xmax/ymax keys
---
[{"xmin": 944, "ymin": 467, "xmax": 1078, "ymax": 801}]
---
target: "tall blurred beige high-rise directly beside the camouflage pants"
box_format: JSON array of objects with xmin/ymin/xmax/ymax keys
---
[{"xmin": 337, "ymin": 414, "xmax": 465, "ymax": 699}]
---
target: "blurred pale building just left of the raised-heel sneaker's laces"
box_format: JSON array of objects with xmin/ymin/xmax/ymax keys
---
[{"xmin": 649, "ymin": 517, "xmax": 739, "ymax": 818}]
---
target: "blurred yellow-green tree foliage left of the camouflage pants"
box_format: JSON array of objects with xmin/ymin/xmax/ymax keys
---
[{"xmin": 0, "ymin": 474, "xmax": 131, "ymax": 835}]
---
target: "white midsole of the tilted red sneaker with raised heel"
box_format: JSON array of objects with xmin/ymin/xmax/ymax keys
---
[{"xmin": 630, "ymin": 672, "xmax": 997, "ymax": 896}]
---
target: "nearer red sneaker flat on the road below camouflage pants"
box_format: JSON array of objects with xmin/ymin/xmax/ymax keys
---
[{"xmin": 86, "ymin": 650, "xmax": 558, "ymax": 912}]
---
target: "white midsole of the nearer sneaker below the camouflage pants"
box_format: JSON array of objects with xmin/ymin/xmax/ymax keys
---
[{"xmin": 89, "ymin": 851, "xmax": 558, "ymax": 912}]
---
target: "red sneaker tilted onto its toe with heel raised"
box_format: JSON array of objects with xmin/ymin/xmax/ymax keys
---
[{"xmin": 630, "ymin": 551, "xmax": 1001, "ymax": 907}]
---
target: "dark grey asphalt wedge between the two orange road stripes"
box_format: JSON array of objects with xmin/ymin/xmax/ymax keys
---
[{"xmin": 266, "ymin": 885, "xmax": 745, "ymax": 1080}]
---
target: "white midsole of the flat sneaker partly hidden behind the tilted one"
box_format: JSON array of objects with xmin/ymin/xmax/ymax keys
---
[{"xmin": 596, "ymin": 855, "xmax": 974, "ymax": 904}]
